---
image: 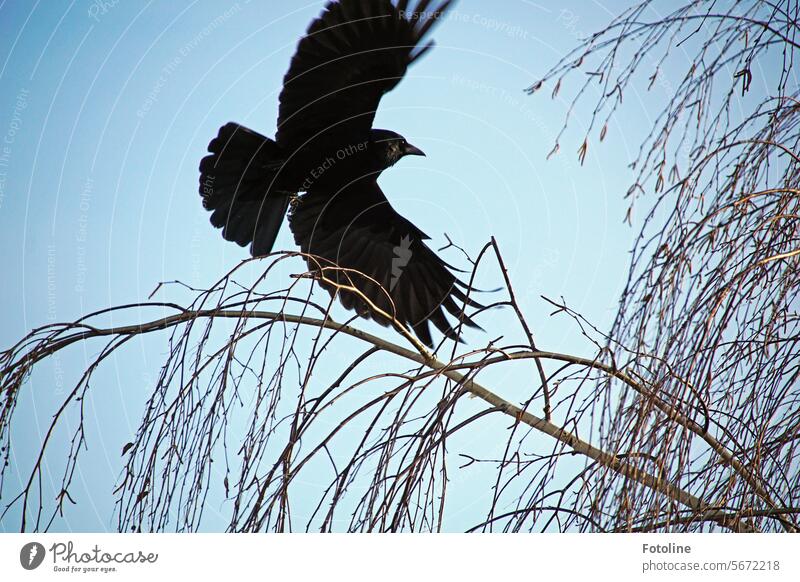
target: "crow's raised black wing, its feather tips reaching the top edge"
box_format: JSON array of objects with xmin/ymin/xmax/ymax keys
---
[{"xmin": 276, "ymin": 0, "xmax": 452, "ymax": 151}]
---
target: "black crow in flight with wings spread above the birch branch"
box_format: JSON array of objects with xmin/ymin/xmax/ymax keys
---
[{"xmin": 200, "ymin": 0, "xmax": 480, "ymax": 346}]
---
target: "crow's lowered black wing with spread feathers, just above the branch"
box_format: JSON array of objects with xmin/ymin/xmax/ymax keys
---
[{"xmin": 289, "ymin": 176, "xmax": 481, "ymax": 346}]
